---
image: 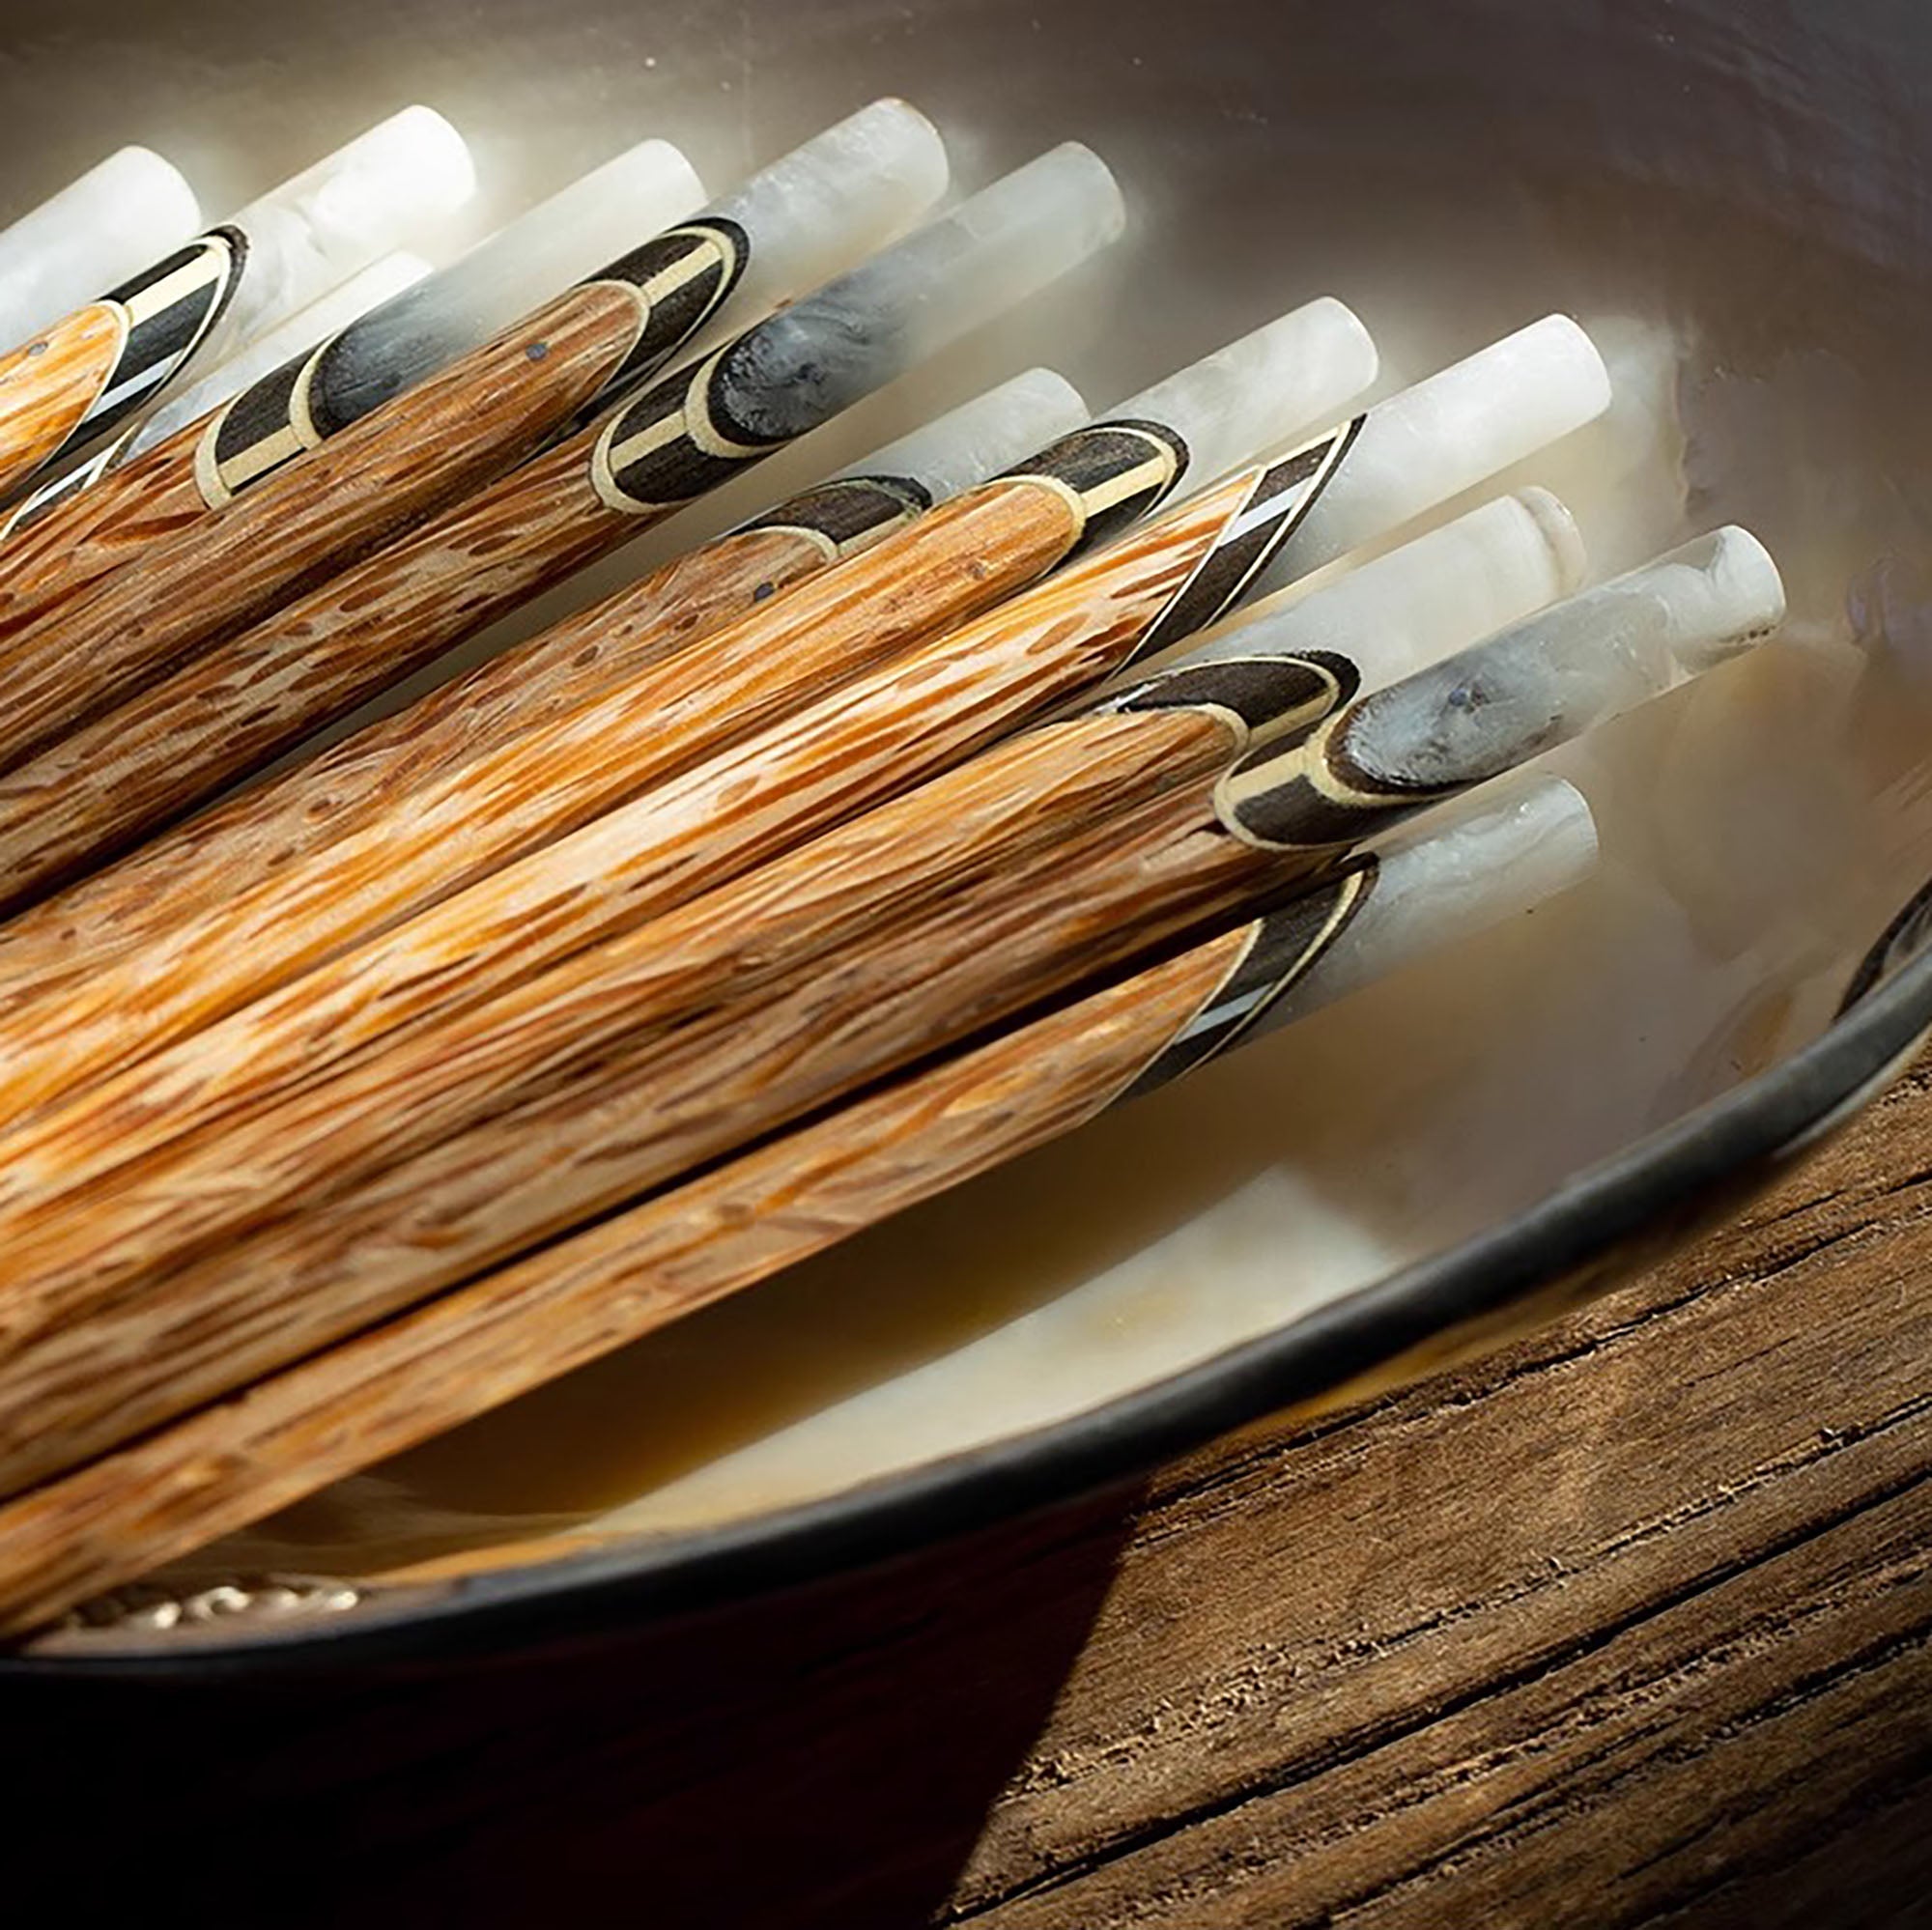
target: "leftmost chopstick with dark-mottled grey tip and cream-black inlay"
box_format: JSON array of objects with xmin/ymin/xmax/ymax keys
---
[{"xmin": 0, "ymin": 129, "xmax": 705, "ymax": 549}]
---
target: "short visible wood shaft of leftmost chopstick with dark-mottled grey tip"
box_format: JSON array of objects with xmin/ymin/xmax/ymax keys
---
[{"xmin": 0, "ymin": 423, "xmax": 209, "ymax": 639}]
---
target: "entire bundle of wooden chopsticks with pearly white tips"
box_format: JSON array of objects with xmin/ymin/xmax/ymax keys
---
[{"xmin": 0, "ymin": 100, "xmax": 1783, "ymax": 1632}]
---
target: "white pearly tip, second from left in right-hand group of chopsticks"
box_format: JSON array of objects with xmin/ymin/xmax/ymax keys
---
[{"xmin": 1109, "ymin": 296, "xmax": 1381, "ymax": 483}]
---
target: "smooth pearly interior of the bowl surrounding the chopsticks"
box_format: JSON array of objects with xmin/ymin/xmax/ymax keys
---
[{"xmin": 14, "ymin": 0, "xmax": 1932, "ymax": 1661}]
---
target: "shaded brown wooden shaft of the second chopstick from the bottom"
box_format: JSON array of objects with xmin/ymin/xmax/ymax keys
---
[{"xmin": 0, "ymin": 773, "xmax": 1289, "ymax": 1490}]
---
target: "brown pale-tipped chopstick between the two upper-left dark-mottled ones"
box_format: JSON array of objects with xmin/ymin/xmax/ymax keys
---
[{"xmin": 0, "ymin": 102, "xmax": 945, "ymax": 765}]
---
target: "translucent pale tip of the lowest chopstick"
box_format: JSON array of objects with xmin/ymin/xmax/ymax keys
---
[{"xmin": 1264, "ymin": 777, "xmax": 1598, "ymax": 1032}]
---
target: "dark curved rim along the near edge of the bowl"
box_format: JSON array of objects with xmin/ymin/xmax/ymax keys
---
[{"xmin": 18, "ymin": 916, "xmax": 1932, "ymax": 1681}]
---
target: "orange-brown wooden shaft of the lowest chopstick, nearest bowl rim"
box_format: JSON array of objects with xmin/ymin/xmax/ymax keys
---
[{"xmin": 0, "ymin": 931, "xmax": 1246, "ymax": 1636}]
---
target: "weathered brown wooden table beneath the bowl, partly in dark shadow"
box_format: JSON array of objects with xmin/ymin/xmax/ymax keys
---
[{"xmin": 11, "ymin": 1068, "xmax": 1932, "ymax": 1930}]
